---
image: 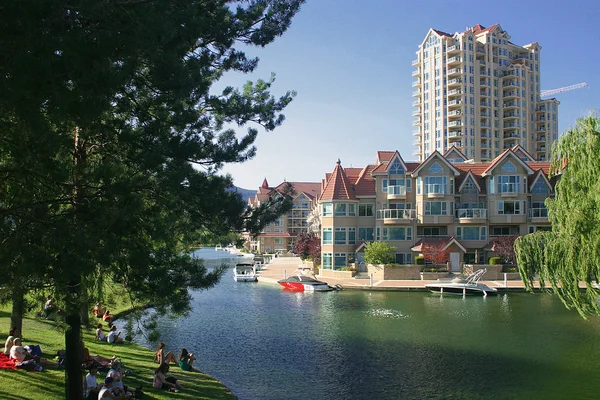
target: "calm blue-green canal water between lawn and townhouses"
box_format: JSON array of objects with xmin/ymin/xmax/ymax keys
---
[{"xmin": 135, "ymin": 249, "xmax": 600, "ymax": 400}]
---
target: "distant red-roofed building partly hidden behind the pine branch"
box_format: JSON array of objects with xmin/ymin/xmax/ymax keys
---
[{"xmin": 246, "ymin": 178, "xmax": 321, "ymax": 254}]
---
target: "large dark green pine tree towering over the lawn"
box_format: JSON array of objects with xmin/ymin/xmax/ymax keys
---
[{"xmin": 0, "ymin": 0, "xmax": 302, "ymax": 399}]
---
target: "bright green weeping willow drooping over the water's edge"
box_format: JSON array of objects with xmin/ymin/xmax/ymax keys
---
[{"xmin": 515, "ymin": 116, "xmax": 600, "ymax": 318}]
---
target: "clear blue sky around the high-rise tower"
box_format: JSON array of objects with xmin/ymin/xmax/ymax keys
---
[{"xmin": 223, "ymin": 0, "xmax": 600, "ymax": 189}]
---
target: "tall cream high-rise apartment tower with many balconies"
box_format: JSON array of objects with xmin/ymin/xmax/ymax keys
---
[{"xmin": 412, "ymin": 24, "xmax": 559, "ymax": 162}]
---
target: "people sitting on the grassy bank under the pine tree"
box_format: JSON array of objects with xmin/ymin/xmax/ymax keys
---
[{"xmin": 4, "ymin": 296, "xmax": 198, "ymax": 400}]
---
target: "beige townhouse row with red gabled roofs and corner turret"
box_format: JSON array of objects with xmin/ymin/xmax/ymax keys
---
[{"xmin": 316, "ymin": 145, "xmax": 554, "ymax": 271}]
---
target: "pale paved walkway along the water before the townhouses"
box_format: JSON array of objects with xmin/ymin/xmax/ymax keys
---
[{"xmin": 258, "ymin": 257, "xmax": 552, "ymax": 292}]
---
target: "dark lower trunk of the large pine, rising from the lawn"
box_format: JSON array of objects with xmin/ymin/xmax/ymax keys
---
[{"xmin": 65, "ymin": 279, "xmax": 83, "ymax": 400}]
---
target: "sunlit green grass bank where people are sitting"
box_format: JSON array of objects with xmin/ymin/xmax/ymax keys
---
[{"xmin": 0, "ymin": 308, "xmax": 236, "ymax": 400}]
